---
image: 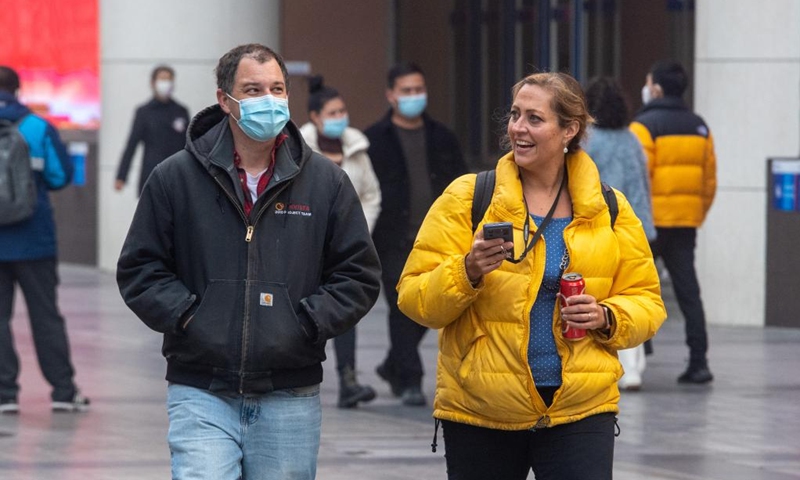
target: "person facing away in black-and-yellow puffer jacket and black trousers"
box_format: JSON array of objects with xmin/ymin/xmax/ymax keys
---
[{"xmin": 631, "ymin": 61, "xmax": 717, "ymax": 383}]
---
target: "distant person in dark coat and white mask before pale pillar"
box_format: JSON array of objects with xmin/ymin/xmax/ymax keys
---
[{"xmin": 114, "ymin": 65, "xmax": 189, "ymax": 195}]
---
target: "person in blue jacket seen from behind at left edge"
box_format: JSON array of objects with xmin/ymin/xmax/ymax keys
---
[{"xmin": 0, "ymin": 66, "xmax": 89, "ymax": 414}]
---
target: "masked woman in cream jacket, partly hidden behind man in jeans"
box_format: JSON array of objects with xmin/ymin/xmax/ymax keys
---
[{"xmin": 300, "ymin": 76, "xmax": 381, "ymax": 408}]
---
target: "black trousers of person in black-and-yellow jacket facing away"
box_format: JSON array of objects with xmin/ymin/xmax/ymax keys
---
[{"xmin": 651, "ymin": 228, "xmax": 708, "ymax": 367}]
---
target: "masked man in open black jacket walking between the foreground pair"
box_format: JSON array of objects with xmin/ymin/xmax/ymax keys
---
[{"xmin": 364, "ymin": 63, "xmax": 467, "ymax": 405}]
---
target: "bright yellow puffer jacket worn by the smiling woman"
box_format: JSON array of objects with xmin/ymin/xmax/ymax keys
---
[{"xmin": 398, "ymin": 152, "xmax": 666, "ymax": 430}]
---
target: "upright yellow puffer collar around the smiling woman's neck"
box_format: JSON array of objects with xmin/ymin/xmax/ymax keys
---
[{"xmin": 492, "ymin": 150, "xmax": 606, "ymax": 228}]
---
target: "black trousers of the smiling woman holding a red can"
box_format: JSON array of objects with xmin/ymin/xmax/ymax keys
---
[{"xmin": 442, "ymin": 413, "xmax": 615, "ymax": 480}]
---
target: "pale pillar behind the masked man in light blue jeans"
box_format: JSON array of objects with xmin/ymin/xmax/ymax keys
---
[{"xmin": 98, "ymin": 0, "xmax": 281, "ymax": 270}]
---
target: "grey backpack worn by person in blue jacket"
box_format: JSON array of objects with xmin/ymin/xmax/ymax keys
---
[{"xmin": 0, "ymin": 117, "xmax": 36, "ymax": 226}]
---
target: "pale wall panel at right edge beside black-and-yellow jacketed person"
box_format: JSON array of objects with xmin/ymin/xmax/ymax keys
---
[{"xmin": 694, "ymin": 0, "xmax": 800, "ymax": 326}]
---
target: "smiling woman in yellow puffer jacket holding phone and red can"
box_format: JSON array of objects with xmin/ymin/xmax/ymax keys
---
[{"xmin": 398, "ymin": 73, "xmax": 666, "ymax": 480}]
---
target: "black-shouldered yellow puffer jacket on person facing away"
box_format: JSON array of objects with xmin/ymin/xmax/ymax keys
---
[{"xmin": 630, "ymin": 97, "xmax": 717, "ymax": 228}]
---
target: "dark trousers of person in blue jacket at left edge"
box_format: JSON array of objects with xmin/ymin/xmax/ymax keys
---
[{"xmin": 0, "ymin": 258, "xmax": 75, "ymax": 402}]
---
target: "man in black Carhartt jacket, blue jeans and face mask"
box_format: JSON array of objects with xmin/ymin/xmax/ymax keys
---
[{"xmin": 117, "ymin": 44, "xmax": 380, "ymax": 480}]
